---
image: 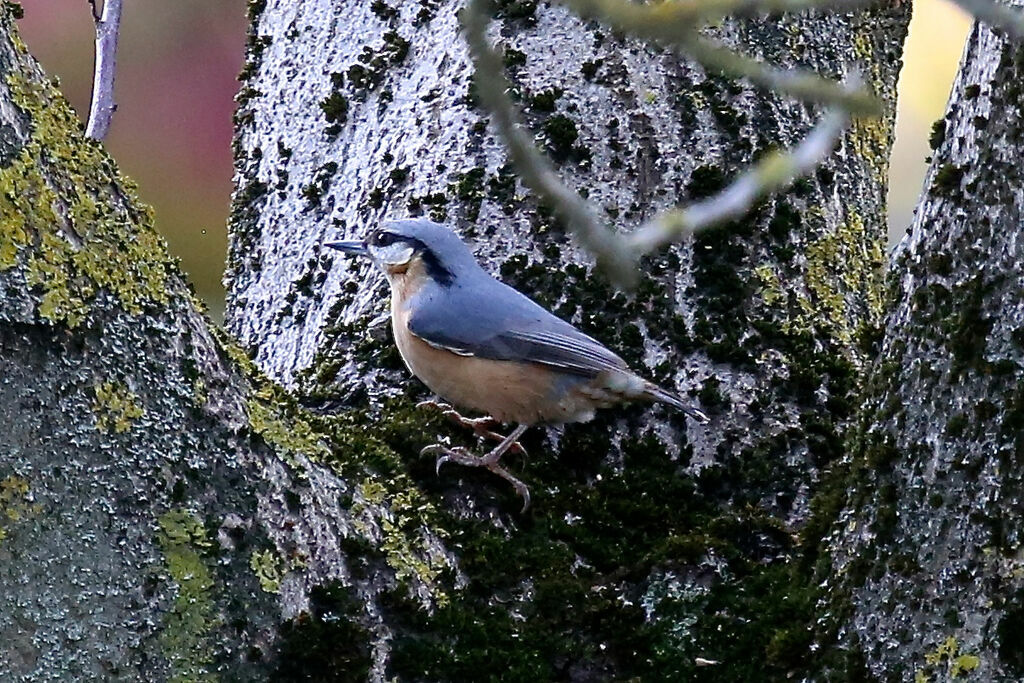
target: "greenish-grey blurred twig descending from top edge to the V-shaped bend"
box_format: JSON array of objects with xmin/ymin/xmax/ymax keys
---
[{"xmin": 463, "ymin": 0, "xmax": 637, "ymax": 286}]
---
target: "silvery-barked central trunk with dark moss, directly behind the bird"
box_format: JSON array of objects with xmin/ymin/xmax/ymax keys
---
[{"xmin": 227, "ymin": 0, "xmax": 908, "ymax": 681}]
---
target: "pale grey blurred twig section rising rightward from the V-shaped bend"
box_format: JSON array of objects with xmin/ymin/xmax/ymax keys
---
[{"xmin": 628, "ymin": 110, "xmax": 850, "ymax": 255}]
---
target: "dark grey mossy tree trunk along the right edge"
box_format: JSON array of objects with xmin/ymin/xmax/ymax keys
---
[{"xmin": 827, "ymin": 13, "xmax": 1024, "ymax": 681}]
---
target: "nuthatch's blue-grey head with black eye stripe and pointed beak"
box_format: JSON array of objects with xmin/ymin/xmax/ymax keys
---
[{"xmin": 324, "ymin": 219, "xmax": 479, "ymax": 287}]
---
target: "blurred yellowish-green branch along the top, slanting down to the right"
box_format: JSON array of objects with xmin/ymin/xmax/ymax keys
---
[{"xmin": 563, "ymin": 0, "xmax": 882, "ymax": 116}]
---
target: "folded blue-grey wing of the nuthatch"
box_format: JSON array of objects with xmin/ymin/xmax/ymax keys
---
[{"xmin": 409, "ymin": 280, "xmax": 627, "ymax": 377}]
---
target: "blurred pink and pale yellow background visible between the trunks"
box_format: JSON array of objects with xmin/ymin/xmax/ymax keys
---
[{"xmin": 19, "ymin": 0, "xmax": 970, "ymax": 319}]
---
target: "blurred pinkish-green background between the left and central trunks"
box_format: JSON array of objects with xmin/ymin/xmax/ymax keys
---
[{"xmin": 18, "ymin": 0, "xmax": 246, "ymax": 317}]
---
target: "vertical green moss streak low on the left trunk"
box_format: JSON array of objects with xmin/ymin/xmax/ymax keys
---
[{"xmin": 157, "ymin": 509, "xmax": 219, "ymax": 683}]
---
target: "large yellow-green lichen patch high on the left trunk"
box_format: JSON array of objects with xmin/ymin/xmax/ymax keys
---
[{"xmin": 0, "ymin": 70, "xmax": 177, "ymax": 328}]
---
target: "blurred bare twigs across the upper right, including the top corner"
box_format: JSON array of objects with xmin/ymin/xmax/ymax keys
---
[{"xmin": 464, "ymin": 0, "xmax": 1024, "ymax": 286}]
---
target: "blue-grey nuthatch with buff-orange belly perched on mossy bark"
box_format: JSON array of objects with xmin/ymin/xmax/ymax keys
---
[{"xmin": 324, "ymin": 218, "xmax": 710, "ymax": 511}]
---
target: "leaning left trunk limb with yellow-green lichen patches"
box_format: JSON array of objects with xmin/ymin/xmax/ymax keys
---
[{"xmin": 0, "ymin": 9, "xmax": 458, "ymax": 681}]
